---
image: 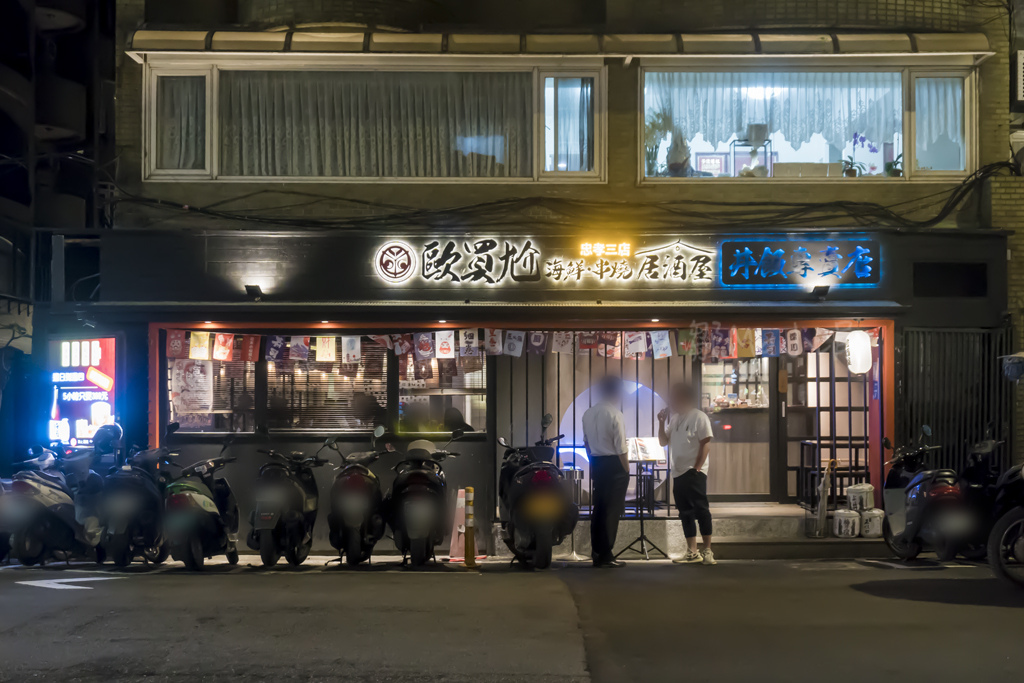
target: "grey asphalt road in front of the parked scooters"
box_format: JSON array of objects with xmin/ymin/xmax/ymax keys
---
[{"xmin": 0, "ymin": 557, "xmax": 1024, "ymax": 683}]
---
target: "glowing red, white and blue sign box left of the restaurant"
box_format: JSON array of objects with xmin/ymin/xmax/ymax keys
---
[{"xmin": 48, "ymin": 337, "xmax": 117, "ymax": 445}]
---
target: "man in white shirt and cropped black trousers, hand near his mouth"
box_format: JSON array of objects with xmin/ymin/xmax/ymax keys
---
[{"xmin": 657, "ymin": 384, "xmax": 716, "ymax": 564}]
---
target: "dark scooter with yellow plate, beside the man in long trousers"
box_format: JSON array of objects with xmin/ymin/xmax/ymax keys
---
[{"xmin": 498, "ymin": 415, "xmax": 580, "ymax": 569}]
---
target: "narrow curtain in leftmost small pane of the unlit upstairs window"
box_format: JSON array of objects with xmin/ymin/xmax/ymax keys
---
[{"xmin": 156, "ymin": 76, "xmax": 206, "ymax": 169}]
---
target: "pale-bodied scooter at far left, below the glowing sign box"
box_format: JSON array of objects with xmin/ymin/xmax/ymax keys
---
[{"xmin": 4, "ymin": 446, "xmax": 104, "ymax": 566}]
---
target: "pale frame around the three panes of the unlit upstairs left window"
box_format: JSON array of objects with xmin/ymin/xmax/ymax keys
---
[{"xmin": 141, "ymin": 53, "xmax": 607, "ymax": 184}]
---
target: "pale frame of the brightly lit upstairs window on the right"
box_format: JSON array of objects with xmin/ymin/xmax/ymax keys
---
[{"xmin": 636, "ymin": 55, "xmax": 978, "ymax": 185}]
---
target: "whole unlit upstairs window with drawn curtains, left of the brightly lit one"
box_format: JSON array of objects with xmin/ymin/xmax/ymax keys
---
[{"xmin": 146, "ymin": 59, "xmax": 604, "ymax": 182}]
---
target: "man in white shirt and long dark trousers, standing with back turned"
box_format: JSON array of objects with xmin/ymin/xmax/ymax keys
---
[{"xmin": 583, "ymin": 375, "xmax": 630, "ymax": 567}]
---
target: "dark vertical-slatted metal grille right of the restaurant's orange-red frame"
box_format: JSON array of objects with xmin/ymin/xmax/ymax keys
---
[{"xmin": 896, "ymin": 328, "xmax": 1013, "ymax": 471}]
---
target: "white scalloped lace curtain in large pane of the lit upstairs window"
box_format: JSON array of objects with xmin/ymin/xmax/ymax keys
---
[{"xmin": 644, "ymin": 72, "xmax": 903, "ymax": 150}]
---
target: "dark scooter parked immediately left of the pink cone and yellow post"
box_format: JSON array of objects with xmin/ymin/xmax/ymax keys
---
[{"xmin": 384, "ymin": 429, "xmax": 463, "ymax": 567}]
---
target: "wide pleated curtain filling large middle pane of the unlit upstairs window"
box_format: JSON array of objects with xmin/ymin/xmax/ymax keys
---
[{"xmin": 219, "ymin": 71, "xmax": 534, "ymax": 177}]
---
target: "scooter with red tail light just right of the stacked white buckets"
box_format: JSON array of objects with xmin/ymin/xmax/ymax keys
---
[{"xmin": 883, "ymin": 425, "xmax": 975, "ymax": 560}]
